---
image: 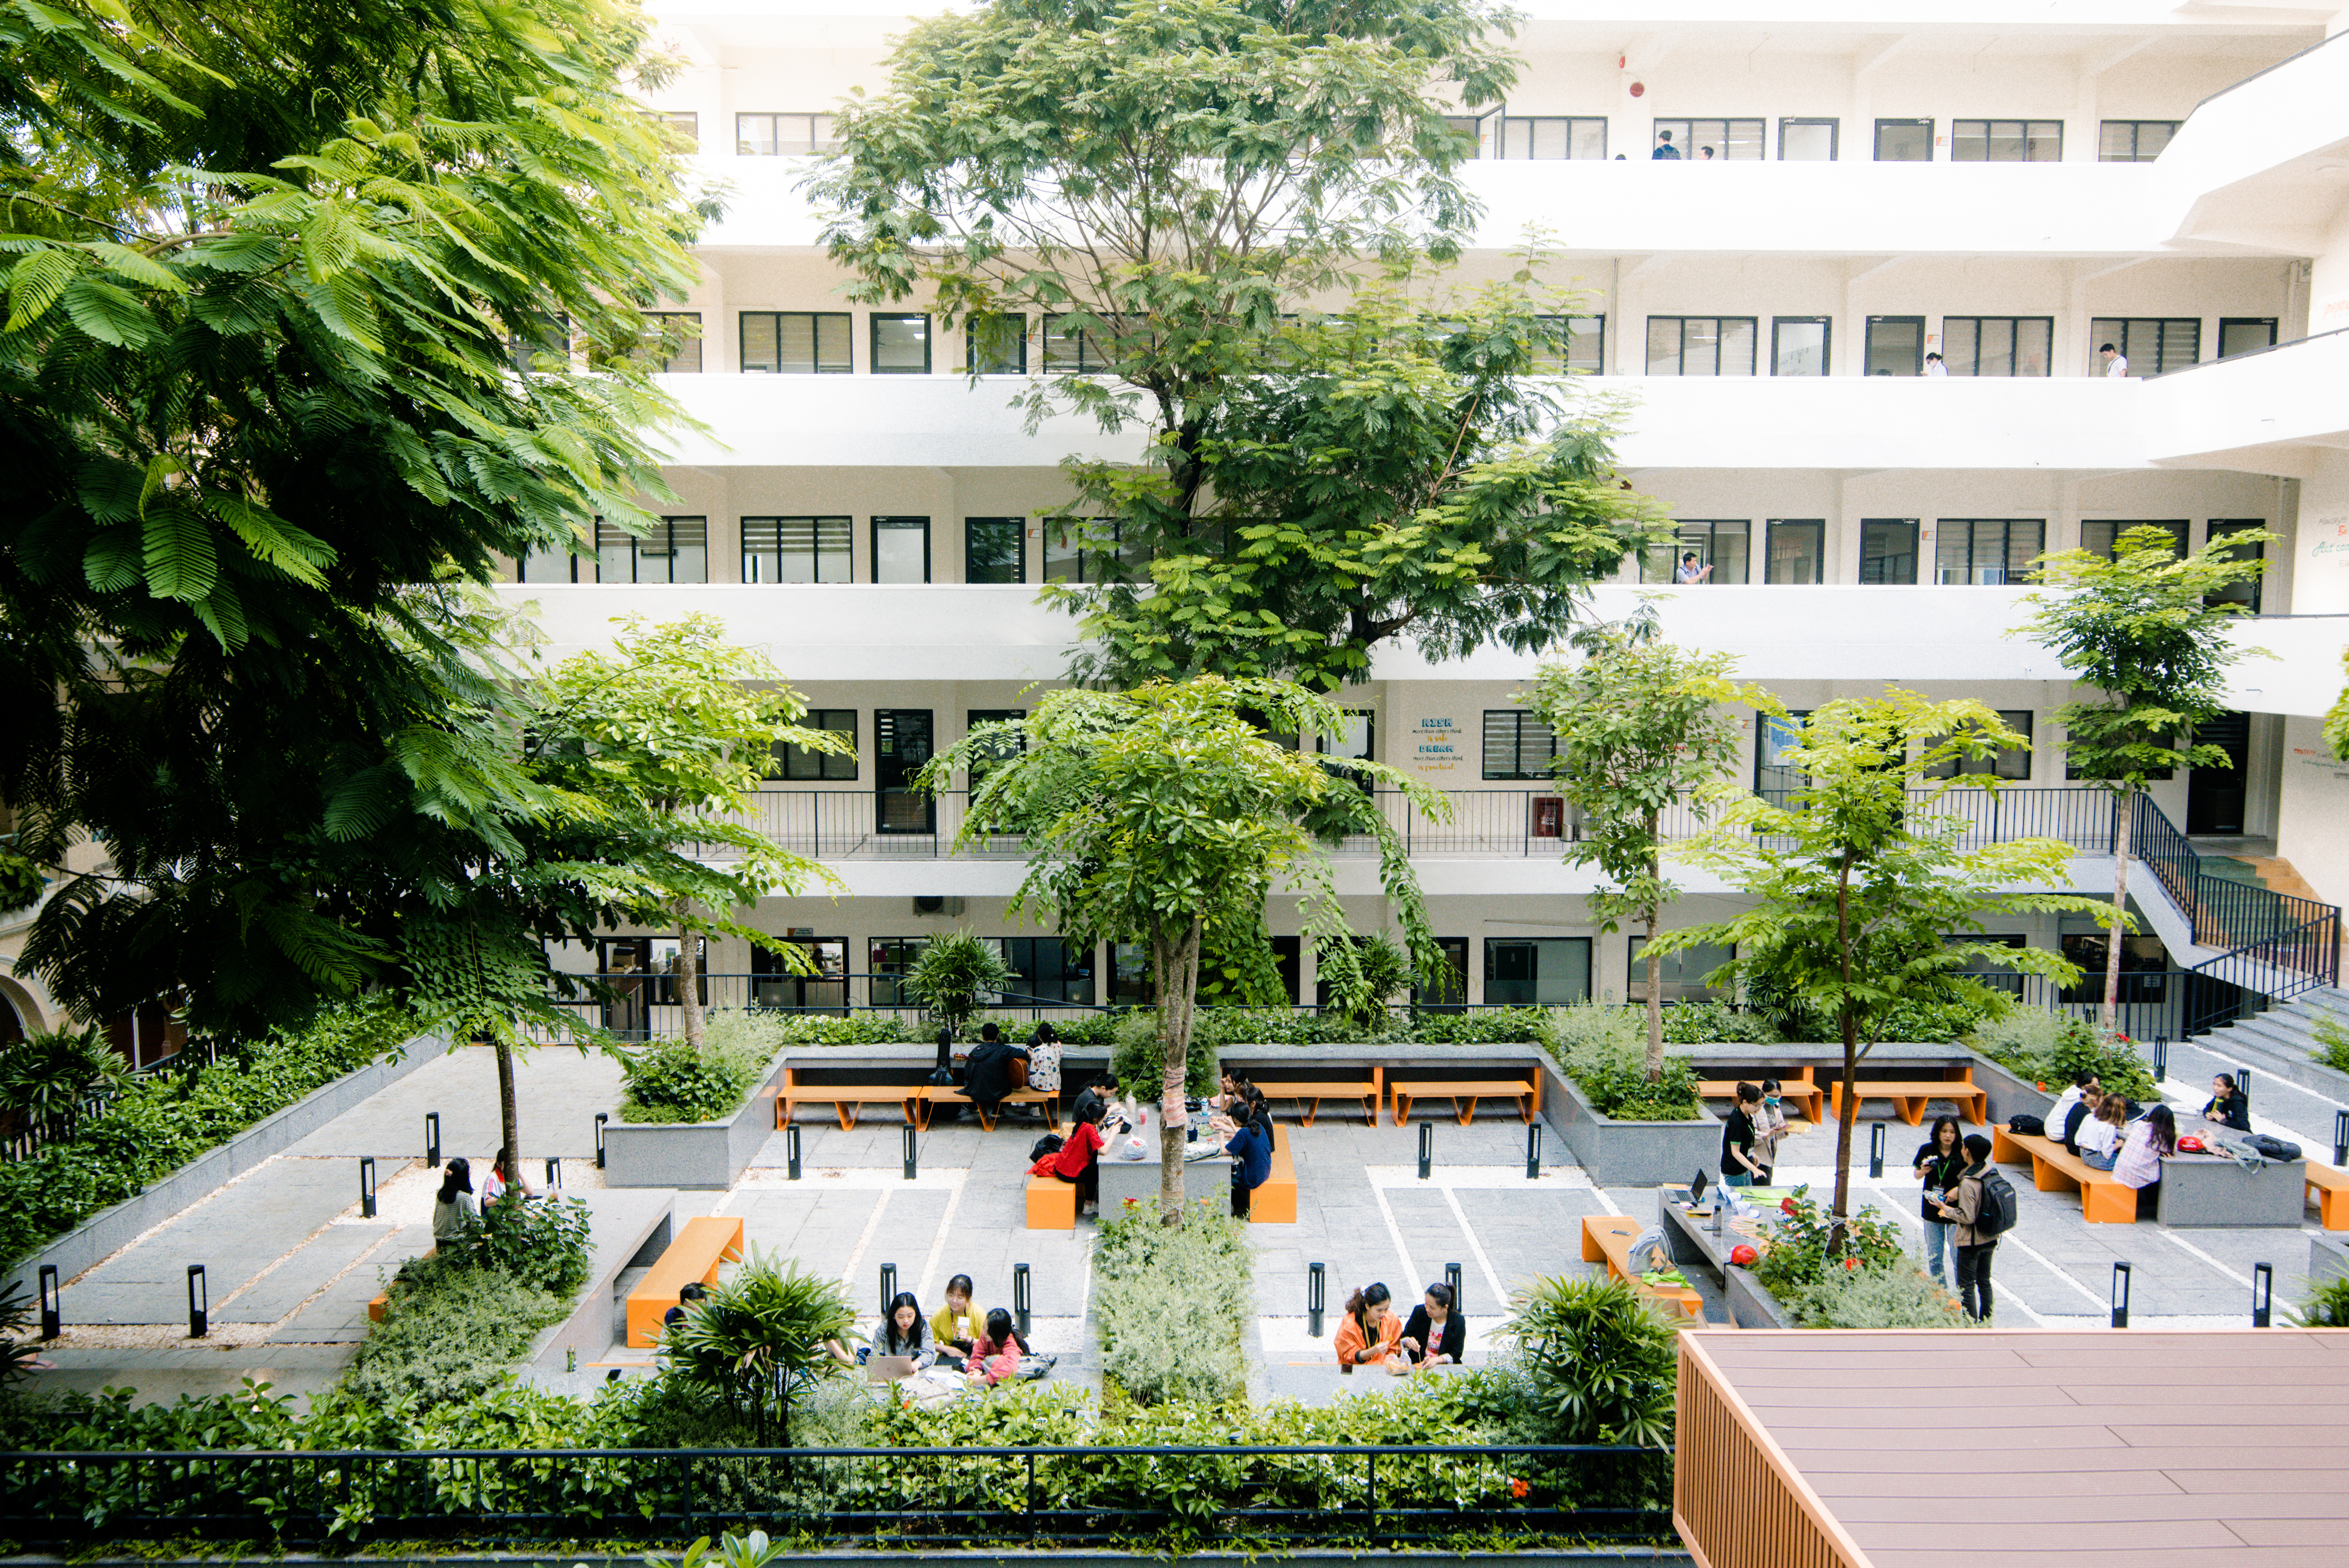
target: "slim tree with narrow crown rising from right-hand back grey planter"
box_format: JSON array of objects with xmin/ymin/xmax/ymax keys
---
[{"xmin": 1532, "ymin": 606, "xmax": 1748, "ymax": 1082}]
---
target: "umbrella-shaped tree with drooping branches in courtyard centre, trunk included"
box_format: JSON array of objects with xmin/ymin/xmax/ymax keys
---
[{"xmin": 921, "ymin": 676, "xmax": 1449, "ymax": 1225}]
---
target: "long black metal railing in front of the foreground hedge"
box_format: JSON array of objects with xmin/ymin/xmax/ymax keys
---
[{"xmin": 0, "ymin": 1443, "xmax": 1672, "ymax": 1547}]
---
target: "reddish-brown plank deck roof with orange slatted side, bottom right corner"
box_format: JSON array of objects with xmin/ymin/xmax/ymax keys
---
[{"xmin": 1682, "ymin": 1329, "xmax": 2349, "ymax": 1568}]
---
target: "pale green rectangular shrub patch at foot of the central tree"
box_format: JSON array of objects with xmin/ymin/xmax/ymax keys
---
[{"xmin": 1092, "ymin": 1204, "xmax": 1257, "ymax": 1403}]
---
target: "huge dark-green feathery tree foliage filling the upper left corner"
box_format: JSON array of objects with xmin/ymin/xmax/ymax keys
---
[{"xmin": 0, "ymin": 0, "xmax": 698, "ymax": 1031}]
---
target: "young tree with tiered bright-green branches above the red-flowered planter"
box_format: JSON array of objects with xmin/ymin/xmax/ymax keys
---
[{"xmin": 1649, "ymin": 690, "xmax": 2105, "ymax": 1220}]
